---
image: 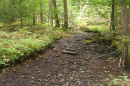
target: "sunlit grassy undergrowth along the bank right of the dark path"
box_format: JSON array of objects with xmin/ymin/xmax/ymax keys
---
[{"xmin": 77, "ymin": 20, "xmax": 130, "ymax": 55}]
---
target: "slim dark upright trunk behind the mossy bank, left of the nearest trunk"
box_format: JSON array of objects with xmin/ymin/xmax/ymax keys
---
[{"xmin": 110, "ymin": 0, "xmax": 115, "ymax": 31}]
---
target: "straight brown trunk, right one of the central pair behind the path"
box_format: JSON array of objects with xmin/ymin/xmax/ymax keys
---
[{"xmin": 63, "ymin": 0, "xmax": 68, "ymax": 29}]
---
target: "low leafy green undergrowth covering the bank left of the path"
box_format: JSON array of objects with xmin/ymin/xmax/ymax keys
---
[{"xmin": 0, "ymin": 27, "xmax": 62, "ymax": 67}]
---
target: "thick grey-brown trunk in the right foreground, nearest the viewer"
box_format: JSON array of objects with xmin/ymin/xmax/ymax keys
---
[{"xmin": 121, "ymin": 0, "xmax": 130, "ymax": 69}]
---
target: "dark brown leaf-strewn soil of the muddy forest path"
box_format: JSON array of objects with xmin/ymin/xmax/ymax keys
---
[{"xmin": 0, "ymin": 32, "xmax": 129, "ymax": 86}]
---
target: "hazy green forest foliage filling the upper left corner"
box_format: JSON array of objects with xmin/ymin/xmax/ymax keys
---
[{"xmin": 0, "ymin": 0, "xmax": 49, "ymax": 25}]
